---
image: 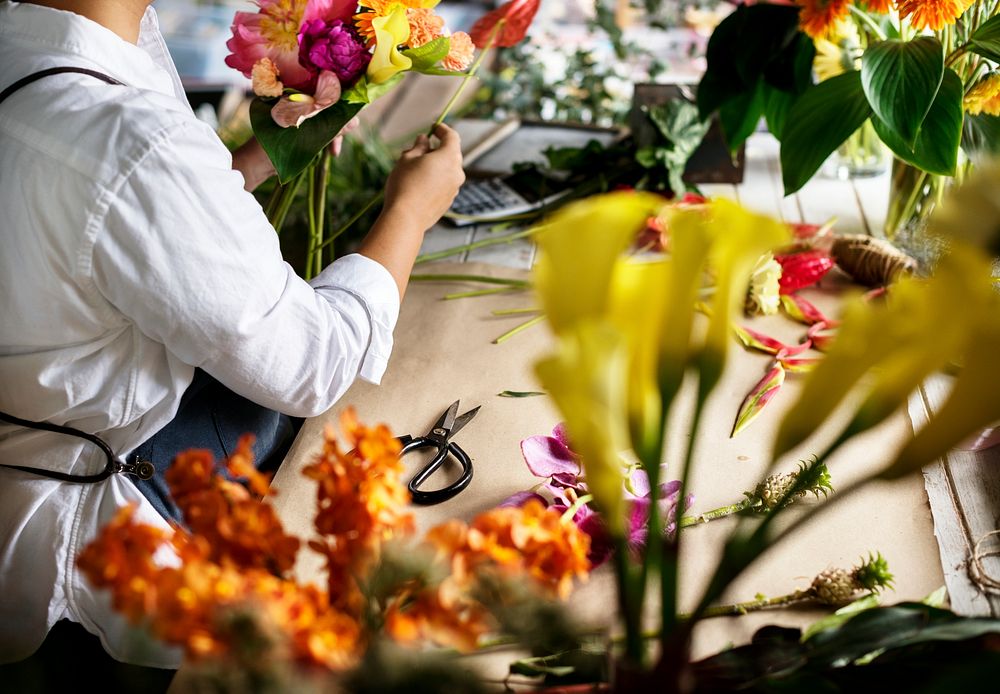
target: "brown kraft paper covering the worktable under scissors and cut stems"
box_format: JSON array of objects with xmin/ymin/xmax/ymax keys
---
[{"xmin": 273, "ymin": 263, "xmax": 944, "ymax": 676}]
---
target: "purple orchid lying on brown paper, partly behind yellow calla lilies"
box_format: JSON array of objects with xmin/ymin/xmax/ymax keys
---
[{"xmin": 500, "ymin": 424, "xmax": 693, "ymax": 568}]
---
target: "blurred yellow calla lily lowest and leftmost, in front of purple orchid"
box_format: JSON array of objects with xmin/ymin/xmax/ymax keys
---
[{"xmin": 535, "ymin": 320, "xmax": 629, "ymax": 537}]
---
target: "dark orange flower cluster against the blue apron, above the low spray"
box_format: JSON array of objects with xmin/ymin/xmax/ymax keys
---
[{"xmin": 165, "ymin": 436, "xmax": 299, "ymax": 576}]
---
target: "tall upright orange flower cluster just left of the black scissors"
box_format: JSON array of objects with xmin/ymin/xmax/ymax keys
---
[{"xmin": 302, "ymin": 408, "xmax": 413, "ymax": 614}]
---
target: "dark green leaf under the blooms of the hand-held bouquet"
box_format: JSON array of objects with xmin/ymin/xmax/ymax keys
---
[{"xmin": 250, "ymin": 97, "xmax": 364, "ymax": 183}]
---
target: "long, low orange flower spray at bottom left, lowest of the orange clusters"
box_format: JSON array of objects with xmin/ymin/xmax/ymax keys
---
[{"xmin": 77, "ymin": 506, "xmax": 362, "ymax": 670}]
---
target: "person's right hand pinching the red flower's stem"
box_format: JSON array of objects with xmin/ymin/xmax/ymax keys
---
[{"xmin": 385, "ymin": 124, "xmax": 465, "ymax": 230}]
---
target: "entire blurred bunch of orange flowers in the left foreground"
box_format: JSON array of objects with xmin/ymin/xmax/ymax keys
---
[{"xmin": 78, "ymin": 410, "xmax": 590, "ymax": 671}]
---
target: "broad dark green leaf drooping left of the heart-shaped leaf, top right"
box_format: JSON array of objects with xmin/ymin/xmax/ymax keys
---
[{"xmin": 781, "ymin": 70, "xmax": 872, "ymax": 195}]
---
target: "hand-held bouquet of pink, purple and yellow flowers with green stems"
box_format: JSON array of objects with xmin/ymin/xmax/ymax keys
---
[{"xmin": 226, "ymin": 0, "xmax": 474, "ymax": 276}]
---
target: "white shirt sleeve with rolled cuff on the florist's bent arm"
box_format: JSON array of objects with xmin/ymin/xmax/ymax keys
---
[{"xmin": 93, "ymin": 122, "xmax": 399, "ymax": 416}]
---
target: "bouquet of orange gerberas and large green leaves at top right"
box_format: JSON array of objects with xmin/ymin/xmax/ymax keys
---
[{"xmin": 698, "ymin": 0, "xmax": 1000, "ymax": 245}]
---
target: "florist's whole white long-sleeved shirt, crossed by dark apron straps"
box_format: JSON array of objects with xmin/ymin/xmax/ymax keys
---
[{"xmin": 0, "ymin": 2, "xmax": 399, "ymax": 667}]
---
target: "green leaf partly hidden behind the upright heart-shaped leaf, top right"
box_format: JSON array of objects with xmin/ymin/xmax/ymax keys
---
[{"xmin": 872, "ymin": 70, "xmax": 962, "ymax": 176}]
